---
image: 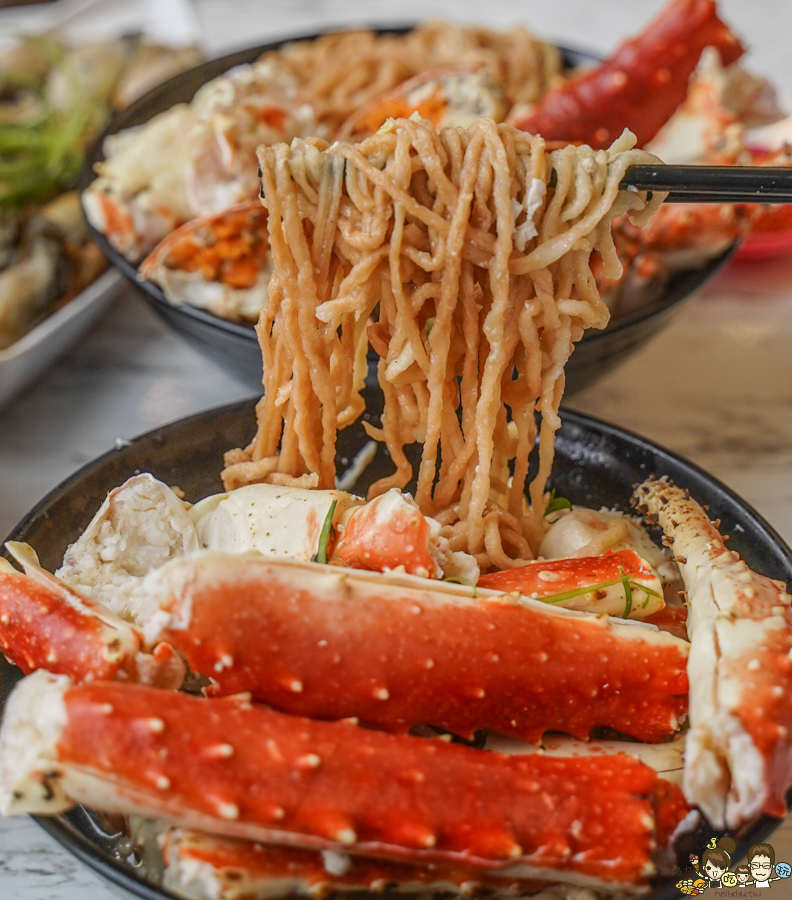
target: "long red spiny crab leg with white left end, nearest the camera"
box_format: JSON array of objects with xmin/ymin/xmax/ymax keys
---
[{"xmin": 0, "ymin": 671, "xmax": 676, "ymax": 888}]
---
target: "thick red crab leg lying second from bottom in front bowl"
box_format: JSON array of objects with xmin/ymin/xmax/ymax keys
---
[{"xmin": 144, "ymin": 553, "xmax": 688, "ymax": 741}]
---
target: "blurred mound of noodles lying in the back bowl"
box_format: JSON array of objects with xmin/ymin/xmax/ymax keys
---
[{"xmin": 262, "ymin": 22, "xmax": 560, "ymax": 136}]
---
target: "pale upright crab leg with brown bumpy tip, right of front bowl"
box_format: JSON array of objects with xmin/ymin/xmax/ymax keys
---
[{"xmin": 635, "ymin": 480, "xmax": 792, "ymax": 828}]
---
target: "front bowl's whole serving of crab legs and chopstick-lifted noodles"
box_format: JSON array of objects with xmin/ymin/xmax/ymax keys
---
[{"xmin": 0, "ymin": 112, "xmax": 792, "ymax": 900}]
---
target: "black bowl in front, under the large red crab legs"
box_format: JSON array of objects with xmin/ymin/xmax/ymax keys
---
[{"xmin": 0, "ymin": 400, "xmax": 792, "ymax": 900}]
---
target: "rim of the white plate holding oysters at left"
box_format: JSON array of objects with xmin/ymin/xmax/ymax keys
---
[{"xmin": 0, "ymin": 269, "xmax": 124, "ymax": 407}]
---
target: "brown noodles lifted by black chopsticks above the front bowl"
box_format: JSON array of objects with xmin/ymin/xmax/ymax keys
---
[{"xmin": 224, "ymin": 119, "xmax": 661, "ymax": 568}]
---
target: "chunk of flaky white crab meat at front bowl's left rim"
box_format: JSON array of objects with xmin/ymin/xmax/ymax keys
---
[{"xmin": 55, "ymin": 473, "xmax": 200, "ymax": 622}]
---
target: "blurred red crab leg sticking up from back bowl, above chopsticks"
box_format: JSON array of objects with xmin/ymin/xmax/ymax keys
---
[{"xmin": 512, "ymin": 0, "xmax": 743, "ymax": 148}]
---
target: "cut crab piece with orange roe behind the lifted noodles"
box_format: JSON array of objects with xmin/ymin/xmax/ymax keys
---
[{"xmin": 338, "ymin": 65, "xmax": 506, "ymax": 142}]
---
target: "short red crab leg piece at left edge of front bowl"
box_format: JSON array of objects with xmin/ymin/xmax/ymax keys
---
[{"xmin": 0, "ymin": 542, "xmax": 184, "ymax": 688}]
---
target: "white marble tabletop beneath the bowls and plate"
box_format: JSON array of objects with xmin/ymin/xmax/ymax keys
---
[{"xmin": 0, "ymin": 0, "xmax": 792, "ymax": 900}]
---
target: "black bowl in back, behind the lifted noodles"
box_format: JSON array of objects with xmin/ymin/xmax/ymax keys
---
[{"xmin": 83, "ymin": 27, "xmax": 731, "ymax": 396}]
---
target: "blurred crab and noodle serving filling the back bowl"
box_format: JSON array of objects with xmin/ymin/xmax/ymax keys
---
[{"xmin": 83, "ymin": 0, "xmax": 789, "ymax": 323}]
